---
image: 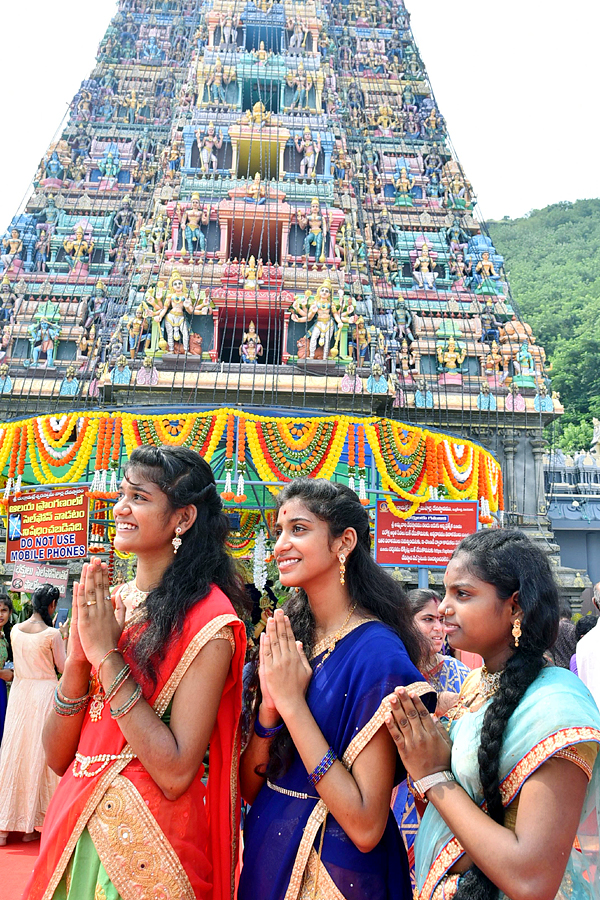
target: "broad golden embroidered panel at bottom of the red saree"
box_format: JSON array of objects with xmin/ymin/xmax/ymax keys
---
[{"xmin": 87, "ymin": 775, "xmax": 195, "ymax": 900}]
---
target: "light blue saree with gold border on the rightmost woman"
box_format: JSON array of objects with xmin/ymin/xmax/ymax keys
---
[{"xmin": 415, "ymin": 668, "xmax": 600, "ymax": 900}]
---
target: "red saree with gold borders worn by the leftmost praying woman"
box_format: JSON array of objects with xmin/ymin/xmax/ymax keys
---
[{"xmin": 23, "ymin": 587, "xmax": 246, "ymax": 900}]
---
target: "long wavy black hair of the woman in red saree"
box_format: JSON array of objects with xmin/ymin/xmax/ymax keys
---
[{"xmin": 125, "ymin": 446, "xmax": 247, "ymax": 686}]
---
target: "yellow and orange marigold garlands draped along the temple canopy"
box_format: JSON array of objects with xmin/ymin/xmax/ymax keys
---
[{"xmin": 0, "ymin": 408, "xmax": 504, "ymax": 524}]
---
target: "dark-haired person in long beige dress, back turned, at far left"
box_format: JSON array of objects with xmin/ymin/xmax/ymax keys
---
[{"xmin": 0, "ymin": 584, "xmax": 65, "ymax": 846}]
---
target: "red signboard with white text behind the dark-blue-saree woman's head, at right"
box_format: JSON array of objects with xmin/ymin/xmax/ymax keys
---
[{"xmin": 375, "ymin": 500, "xmax": 478, "ymax": 569}]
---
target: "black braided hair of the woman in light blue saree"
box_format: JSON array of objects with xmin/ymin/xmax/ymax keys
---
[{"xmin": 453, "ymin": 529, "xmax": 559, "ymax": 900}]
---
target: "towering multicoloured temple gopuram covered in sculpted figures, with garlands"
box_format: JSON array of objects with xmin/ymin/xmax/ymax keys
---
[{"xmin": 0, "ymin": 0, "xmax": 579, "ymax": 595}]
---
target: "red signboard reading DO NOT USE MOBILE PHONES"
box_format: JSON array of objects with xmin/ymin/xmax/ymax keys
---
[{"xmin": 6, "ymin": 488, "xmax": 89, "ymax": 563}]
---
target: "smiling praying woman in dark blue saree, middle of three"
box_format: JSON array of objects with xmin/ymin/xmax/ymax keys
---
[{"xmin": 238, "ymin": 479, "xmax": 435, "ymax": 900}]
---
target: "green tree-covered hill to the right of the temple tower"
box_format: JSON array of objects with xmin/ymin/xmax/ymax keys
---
[{"xmin": 487, "ymin": 200, "xmax": 600, "ymax": 450}]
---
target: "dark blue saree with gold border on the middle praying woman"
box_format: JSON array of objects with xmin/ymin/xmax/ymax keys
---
[{"xmin": 238, "ymin": 622, "xmax": 436, "ymax": 900}]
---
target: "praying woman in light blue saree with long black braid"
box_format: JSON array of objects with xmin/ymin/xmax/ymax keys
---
[{"xmin": 386, "ymin": 530, "xmax": 600, "ymax": 900}]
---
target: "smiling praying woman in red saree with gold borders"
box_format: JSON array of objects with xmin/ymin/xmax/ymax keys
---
[{"xmin": 24, "ymin": 447, "xmax": 245, "ymax": 900}]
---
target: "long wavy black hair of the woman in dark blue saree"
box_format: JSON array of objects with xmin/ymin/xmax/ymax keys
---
[{"xmin": 251, "ymin": 478, "xmax": 424, "ymax": 778}]
